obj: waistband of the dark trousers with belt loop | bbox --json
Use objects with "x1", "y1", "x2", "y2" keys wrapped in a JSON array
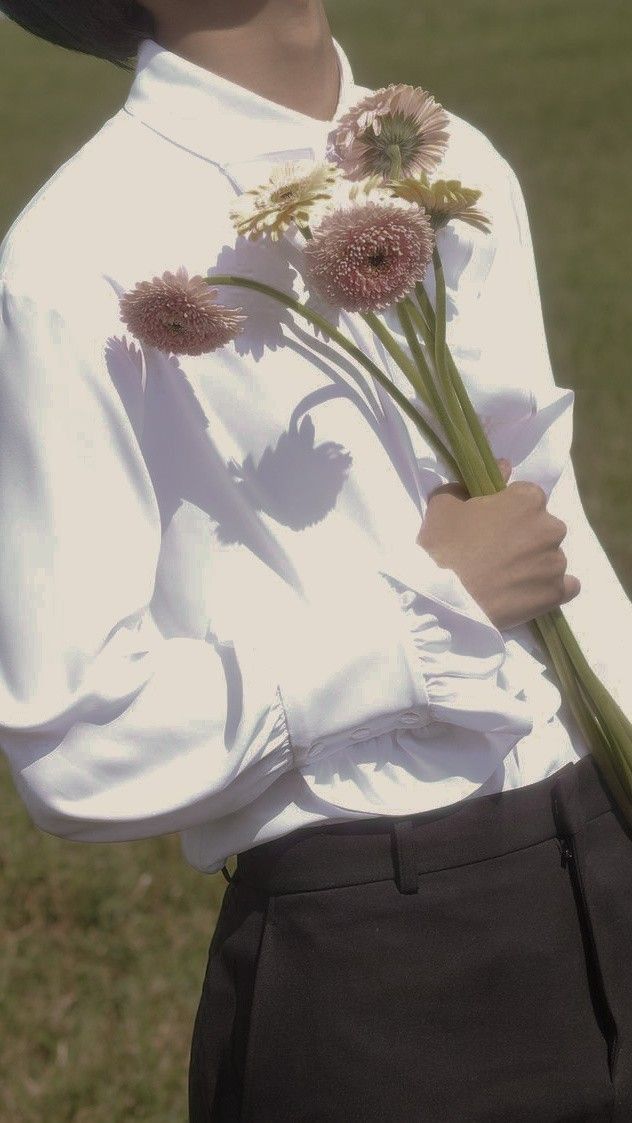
[{"x1": 233, "y1": 755, "x2": 615, "y2": 894}]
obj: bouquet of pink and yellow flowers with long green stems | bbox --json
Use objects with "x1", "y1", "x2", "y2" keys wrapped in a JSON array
[{"x1": 120, "y1": 79, "x2": 632, "y2": 824}]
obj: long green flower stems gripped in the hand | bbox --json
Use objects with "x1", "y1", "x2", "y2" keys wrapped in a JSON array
[{"x1": 209, "y1": 248, "x2": 632, "y2": 827}]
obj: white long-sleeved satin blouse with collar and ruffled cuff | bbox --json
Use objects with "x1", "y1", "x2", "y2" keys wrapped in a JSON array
[{"x1": 0, "y1": 39, "x2": 632, "y2": 873}]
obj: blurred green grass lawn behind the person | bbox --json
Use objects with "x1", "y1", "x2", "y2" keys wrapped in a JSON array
[{"x1": 0, "y1": 0, "x2": 632, "y2": 1123}]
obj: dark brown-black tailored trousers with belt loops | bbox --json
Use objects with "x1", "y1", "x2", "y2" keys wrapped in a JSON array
[{"x1": 189, "y1": 756, "x2": 632, "y2": 1123}]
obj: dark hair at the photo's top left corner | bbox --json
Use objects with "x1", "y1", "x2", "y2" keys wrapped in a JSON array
[{"x1": 0, "y1": 0, "x2": 156, "y2": 71}]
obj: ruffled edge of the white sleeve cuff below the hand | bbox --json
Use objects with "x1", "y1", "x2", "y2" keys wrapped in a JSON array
[{"x1": 294, "y1": 570, "x2": 543, "y2": 815}]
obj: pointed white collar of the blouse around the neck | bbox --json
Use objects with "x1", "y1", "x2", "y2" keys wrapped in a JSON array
[{"x1": 123, "y1": 38, "x2": 363, "y2": 167}]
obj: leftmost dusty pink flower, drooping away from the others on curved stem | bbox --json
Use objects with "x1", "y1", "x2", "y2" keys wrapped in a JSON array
[{"x1": 120, "y1": 266, "x2": 246, "y2": 355}]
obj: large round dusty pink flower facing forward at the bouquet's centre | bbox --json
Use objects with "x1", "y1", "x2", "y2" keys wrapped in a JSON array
[{"x1": 304, "y1": 202, "x2": 434, "y2": 312}]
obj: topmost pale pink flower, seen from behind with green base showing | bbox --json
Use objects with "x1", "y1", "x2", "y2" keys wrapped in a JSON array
[{"x1": 328, "y1": 84, "x2": 449, "y2": 180}]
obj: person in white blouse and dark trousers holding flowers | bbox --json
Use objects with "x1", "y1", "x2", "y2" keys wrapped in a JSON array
[{"x1": 0, "y1": 0, "x2": 632, "y2": 1123}]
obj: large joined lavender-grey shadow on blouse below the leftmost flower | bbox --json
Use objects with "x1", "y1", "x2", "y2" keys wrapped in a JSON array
[{"x1": 106, "y1": 336, "x2": 351, "y2": 570}]
